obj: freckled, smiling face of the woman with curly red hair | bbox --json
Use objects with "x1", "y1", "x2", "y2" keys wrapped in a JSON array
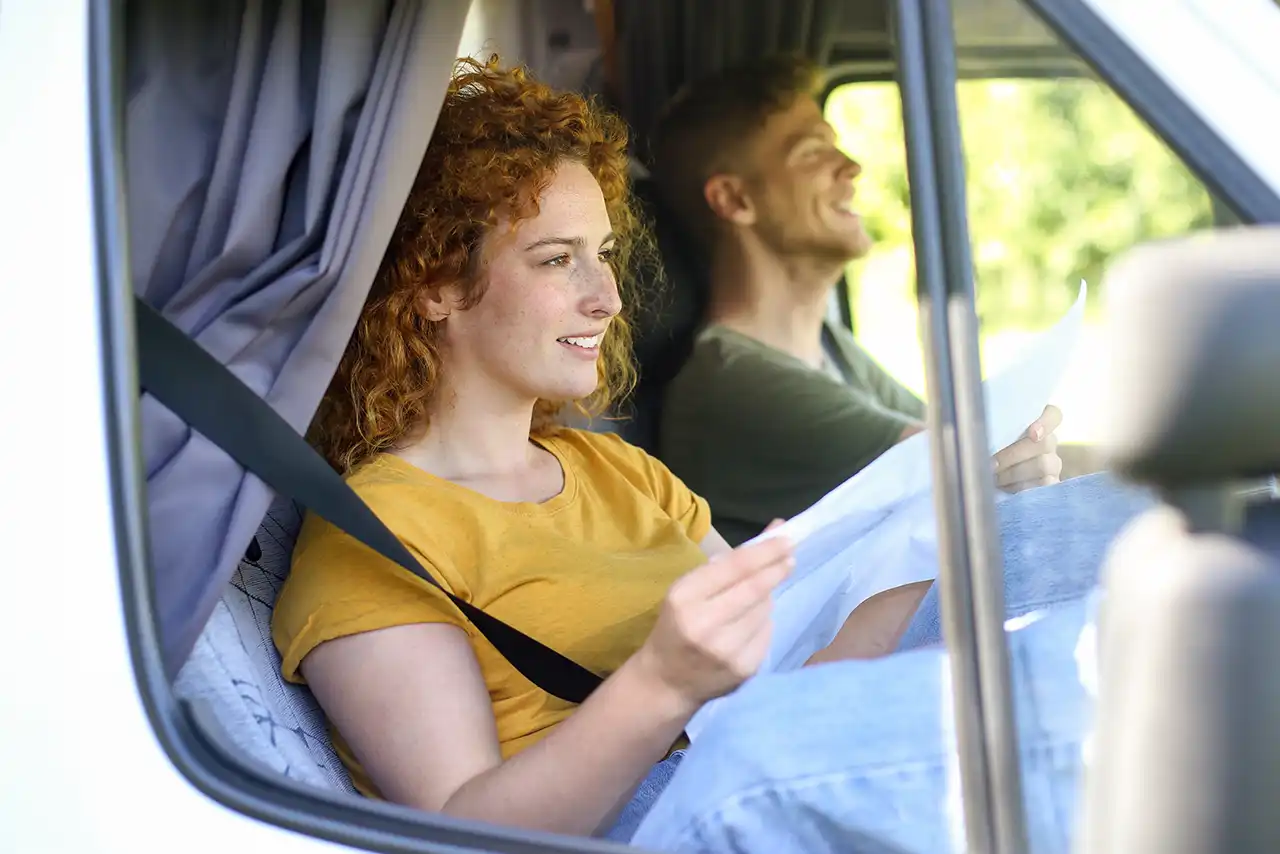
[{"x1": 444, "y1": 161, "x2": 622, "y2": 403}]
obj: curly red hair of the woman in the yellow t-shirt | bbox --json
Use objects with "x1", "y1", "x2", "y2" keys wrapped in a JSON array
[{"x1": 310, "y1": 56, "x2": 653, "y2": 472}]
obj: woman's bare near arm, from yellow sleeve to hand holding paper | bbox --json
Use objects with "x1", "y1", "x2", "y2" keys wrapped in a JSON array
[{"x1": 302, "y1": 540, "x2": 791, "y2": 835}]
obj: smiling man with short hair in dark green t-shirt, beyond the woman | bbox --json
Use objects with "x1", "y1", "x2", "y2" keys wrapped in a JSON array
[{"x1": 653, "y1": 56, "x2": 1062, "y2": 544}]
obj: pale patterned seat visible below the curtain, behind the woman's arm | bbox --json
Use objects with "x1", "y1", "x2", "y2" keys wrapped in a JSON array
[{"x1": 174, "y1": 499, "x2": 356, "y2": 795}]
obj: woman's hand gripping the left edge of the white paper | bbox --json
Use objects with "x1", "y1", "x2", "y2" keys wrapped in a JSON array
[{"x1": 632, "y1": 536, "x2": 795, "y2": 713}]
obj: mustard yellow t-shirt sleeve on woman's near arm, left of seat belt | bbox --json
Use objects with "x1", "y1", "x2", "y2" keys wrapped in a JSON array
[{"x1": 271, "y1": 513, "x2": 475, "y2": 684}]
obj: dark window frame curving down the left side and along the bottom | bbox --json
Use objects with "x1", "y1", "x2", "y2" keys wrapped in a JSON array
[{"x1": 97, "y1": 0, "x2": 1280, "y2": 853}]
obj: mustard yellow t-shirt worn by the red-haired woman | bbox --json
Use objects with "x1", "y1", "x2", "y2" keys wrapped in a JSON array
[{"x1": 271, "y1": 430, "x2": 710, "y2": 796}]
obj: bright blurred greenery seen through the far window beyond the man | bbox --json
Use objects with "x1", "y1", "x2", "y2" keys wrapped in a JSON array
[{"x1": 826, "y1": 79, "x2": 1213, "y2": 444}]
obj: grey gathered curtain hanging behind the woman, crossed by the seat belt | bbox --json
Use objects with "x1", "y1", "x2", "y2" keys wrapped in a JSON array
[{"x1": 124, "y1": 0, "x2": 468, "y2": 675}]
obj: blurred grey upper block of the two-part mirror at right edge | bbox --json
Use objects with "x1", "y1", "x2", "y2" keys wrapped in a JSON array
[{"x1": 1102, "y1": 227, "x2": 1280, "y2": 487}]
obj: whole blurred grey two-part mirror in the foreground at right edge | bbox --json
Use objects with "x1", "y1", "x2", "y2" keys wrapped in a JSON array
[{"x1": 1076, "y1": 228, "x2": 1280, "y2": 854}]
